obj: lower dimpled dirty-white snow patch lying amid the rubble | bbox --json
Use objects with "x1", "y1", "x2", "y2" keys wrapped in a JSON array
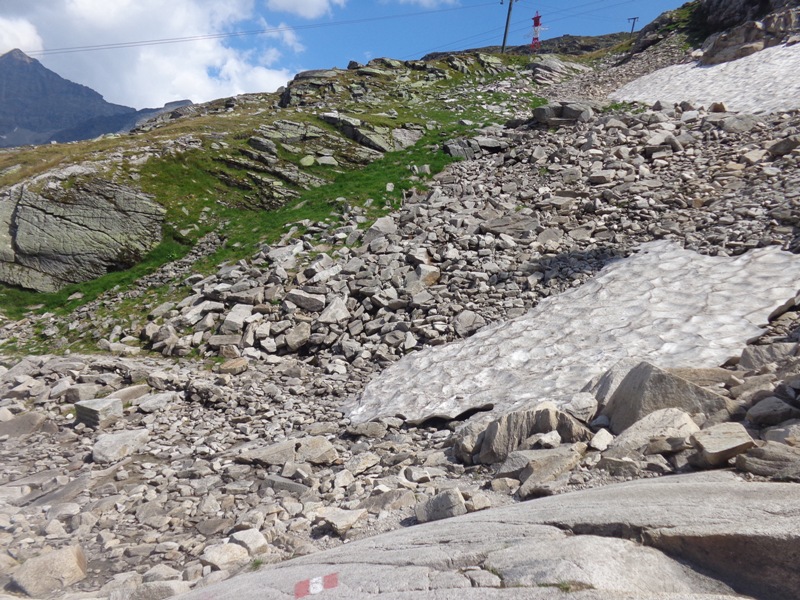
[{"x1": 343, "y1": 241, "x2": 800, "y2": 423}]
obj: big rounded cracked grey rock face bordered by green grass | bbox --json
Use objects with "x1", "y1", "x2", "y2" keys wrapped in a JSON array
[{"x1": 0, "y1": 179, "x2": 165, "y2": 292}]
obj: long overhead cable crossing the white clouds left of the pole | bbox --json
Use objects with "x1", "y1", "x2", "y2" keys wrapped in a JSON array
[{"x1": 25, "y1": 2, "x2": 494, "y2": 56}]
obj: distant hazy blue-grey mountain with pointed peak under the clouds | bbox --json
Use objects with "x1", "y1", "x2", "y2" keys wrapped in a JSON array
[{"x1": 0, "y1": 49, "x2": 191, "y2": 148}]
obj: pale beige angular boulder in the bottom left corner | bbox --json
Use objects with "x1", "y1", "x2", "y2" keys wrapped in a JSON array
[{"x1": 11, "y1": 546, "x2": 86, "y2": 598}]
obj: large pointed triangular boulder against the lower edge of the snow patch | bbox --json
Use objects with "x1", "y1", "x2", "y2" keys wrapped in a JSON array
[{"x1": 603, "y1": 362, "x2": 734, "y2": 434}]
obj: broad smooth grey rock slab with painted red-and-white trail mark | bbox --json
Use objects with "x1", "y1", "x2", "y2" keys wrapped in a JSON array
[{"x1": 173, "y1": 473, "x2": 800, "y2": 600}]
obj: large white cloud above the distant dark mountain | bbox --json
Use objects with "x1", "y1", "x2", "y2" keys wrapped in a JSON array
[{"x1": 0, "y1": 0, "x2": 302, "y2": 108}]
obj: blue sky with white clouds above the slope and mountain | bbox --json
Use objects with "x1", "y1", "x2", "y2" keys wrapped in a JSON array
[{"x1": 0, "y1": 0, "x2": 683, "y2": 108}]
